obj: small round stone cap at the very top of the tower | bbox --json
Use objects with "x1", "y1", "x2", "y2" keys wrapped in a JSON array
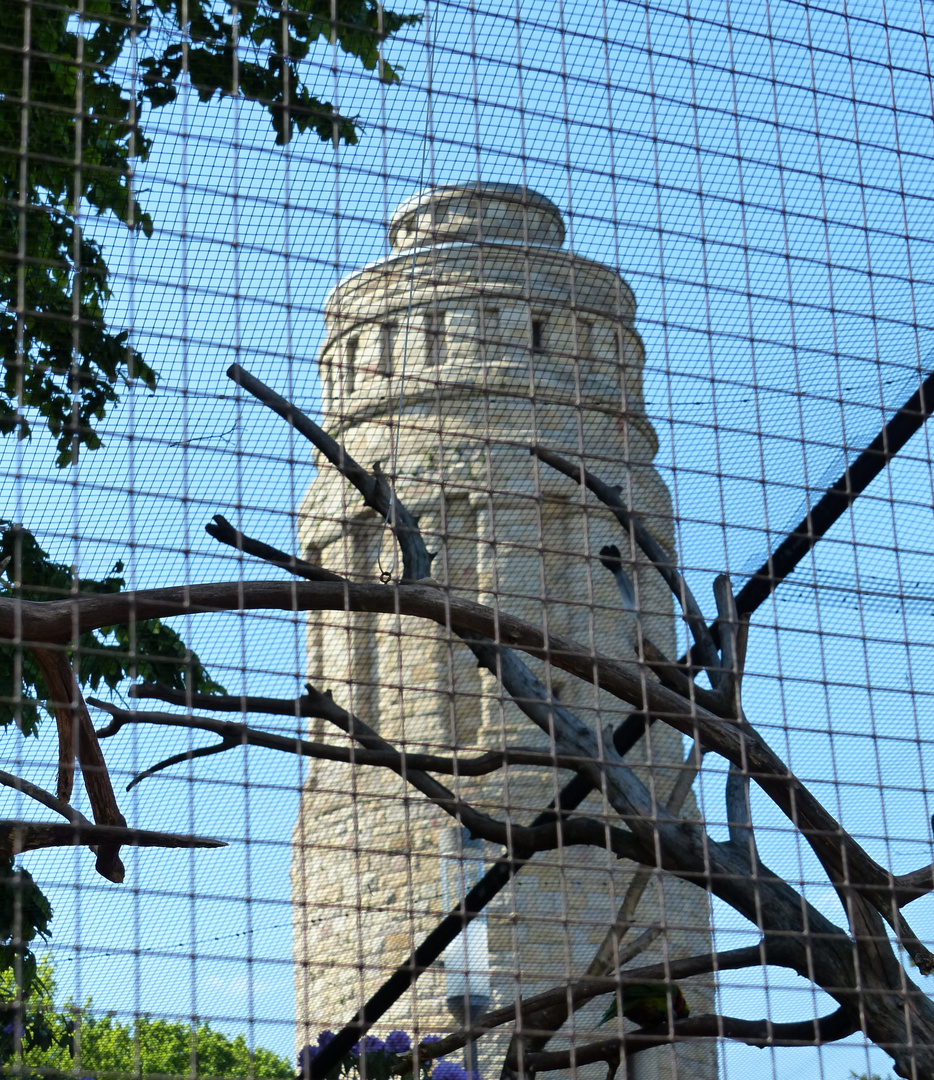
[{"x1": 389, "y1": 184, "x2": 565, "y2": 252}]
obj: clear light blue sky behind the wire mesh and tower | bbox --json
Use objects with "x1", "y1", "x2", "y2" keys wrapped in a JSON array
[{"x1": 0, "y1": 0, "x2": 934, "y2": 1080}]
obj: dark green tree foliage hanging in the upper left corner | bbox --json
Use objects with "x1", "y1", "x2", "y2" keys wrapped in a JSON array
[{"x1": 0, "y1": 0, "x2": 418, "y2": 467}]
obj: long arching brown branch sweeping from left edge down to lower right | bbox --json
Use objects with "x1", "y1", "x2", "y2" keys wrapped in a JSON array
[{"x1": 0, "y1": 581, "x2": 902, "y2": 911}]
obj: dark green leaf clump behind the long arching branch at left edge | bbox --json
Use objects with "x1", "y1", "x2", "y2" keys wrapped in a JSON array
[{"x1": 0, "y1": 521, "x2": 225, "y2": 734}]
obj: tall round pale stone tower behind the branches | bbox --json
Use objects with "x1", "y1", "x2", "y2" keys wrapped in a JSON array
[{"x1": 293, "y1": 185, "x2": 717, "y2": 1080}]
